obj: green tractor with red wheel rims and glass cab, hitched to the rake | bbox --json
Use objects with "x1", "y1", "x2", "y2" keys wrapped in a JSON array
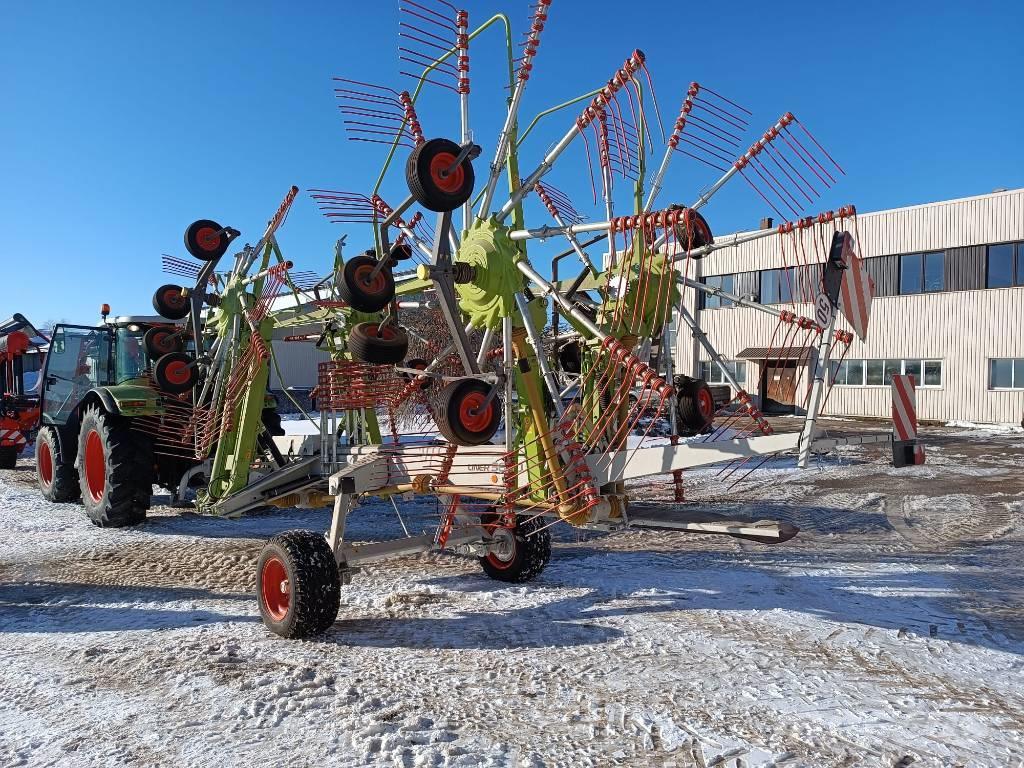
[{"x1": 36, "y1": 315, "x2": 197, "y2": 527}]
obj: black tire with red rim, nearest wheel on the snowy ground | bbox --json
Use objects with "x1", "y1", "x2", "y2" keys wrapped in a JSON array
[{"x1": 256, "y1": 530, "x2": 341, "y2": 639}]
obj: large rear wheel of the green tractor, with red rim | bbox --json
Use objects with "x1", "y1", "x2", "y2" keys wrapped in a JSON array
[{"x1": 75, "y1": 406, "x2": 154, "y2": 528}]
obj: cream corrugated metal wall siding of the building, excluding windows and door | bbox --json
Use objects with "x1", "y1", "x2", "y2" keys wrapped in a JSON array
[{"x1": 679, "y1": 189, "x2": 1024, "y2": 423}]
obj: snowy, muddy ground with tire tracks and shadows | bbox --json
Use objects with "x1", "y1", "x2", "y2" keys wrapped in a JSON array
[{"x1": 0, "y1": 425, "x2": 1024, "y2": 768}]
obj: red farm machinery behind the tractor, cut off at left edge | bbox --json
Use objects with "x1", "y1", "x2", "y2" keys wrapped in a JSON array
[{"x1": 0, "y1": 314, "x2": 41, "y2": 469}]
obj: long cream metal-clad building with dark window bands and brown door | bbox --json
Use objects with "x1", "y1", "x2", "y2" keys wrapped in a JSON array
[{"x1": 675, "y1": 189, "x2": 1024, "y2": 423}]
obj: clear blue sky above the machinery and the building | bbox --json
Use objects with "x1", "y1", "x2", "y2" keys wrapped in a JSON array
[{"x1": 0, "y1": 0, "x2": 1024, "y2": 324}]
